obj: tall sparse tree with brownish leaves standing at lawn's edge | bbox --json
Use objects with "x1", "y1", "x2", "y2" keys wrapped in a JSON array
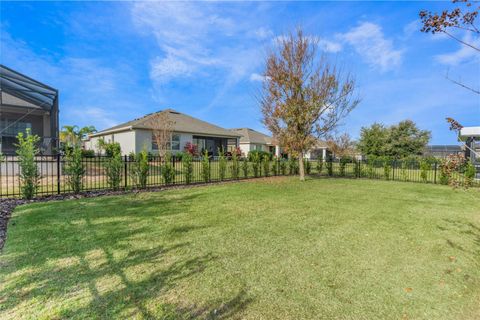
[{"x1": 260, "y1": 29, "x2": 359, "y2": 180}]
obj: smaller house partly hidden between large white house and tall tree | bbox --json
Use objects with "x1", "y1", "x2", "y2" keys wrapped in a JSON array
[{"x1": 230, "y1": 128, "x2": 281, "y2": 157}]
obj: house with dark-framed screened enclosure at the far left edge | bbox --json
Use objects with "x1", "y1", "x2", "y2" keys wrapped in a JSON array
[{"x1": 0, "y1": 64, "x2": 58, "y2": 154}]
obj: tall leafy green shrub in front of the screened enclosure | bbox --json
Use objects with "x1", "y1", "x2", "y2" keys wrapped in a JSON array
[{"x1": 15, "y1": 129, "x2": 40, "y2": 199}]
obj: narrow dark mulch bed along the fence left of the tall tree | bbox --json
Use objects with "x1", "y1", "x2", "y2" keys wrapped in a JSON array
[{"x1": 0, "y1": 177, "x2": 280, "y2": 252}]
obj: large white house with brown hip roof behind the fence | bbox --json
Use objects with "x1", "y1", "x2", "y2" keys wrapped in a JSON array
[{"x1": 85, "y1": 109, "x2": 240, "y2": 156}]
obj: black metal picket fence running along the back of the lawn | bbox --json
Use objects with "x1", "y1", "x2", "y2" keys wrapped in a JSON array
[{"x1": 0, "y1": 155, "x2": 480, "y2": 198}]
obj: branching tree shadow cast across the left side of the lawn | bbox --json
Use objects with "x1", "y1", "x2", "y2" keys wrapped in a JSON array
[{"x1": 0, "y1": 190, "x2": 249, "y2": 318}]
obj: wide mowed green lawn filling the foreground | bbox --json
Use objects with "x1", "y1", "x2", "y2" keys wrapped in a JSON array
[{"x1": 0, "y1": 177, "x2": 480, "y2": 319}]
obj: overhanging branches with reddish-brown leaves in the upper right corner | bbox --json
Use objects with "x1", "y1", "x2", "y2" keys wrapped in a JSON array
[{"x1": 419, "y1": 0, "x2": 480, "y2": 94}]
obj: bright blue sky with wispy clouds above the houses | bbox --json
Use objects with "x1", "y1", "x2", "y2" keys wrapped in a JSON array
[{"x1": 0, "y1": 2, "x2": 480, "y2": 144}]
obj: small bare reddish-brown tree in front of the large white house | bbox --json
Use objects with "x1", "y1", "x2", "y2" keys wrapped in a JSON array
[{"x1": 145, "y1": 112, "x2": 175, "y2": 157}]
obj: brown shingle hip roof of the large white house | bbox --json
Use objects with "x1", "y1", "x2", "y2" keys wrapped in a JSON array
[{"x1": 92, "y1": 109, "x2": 240, "y2": 138}]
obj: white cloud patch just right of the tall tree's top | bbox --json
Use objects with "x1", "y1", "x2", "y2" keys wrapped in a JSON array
[{"x1": 339, "y1": 22, "x2": 403, "y2": 71}]
